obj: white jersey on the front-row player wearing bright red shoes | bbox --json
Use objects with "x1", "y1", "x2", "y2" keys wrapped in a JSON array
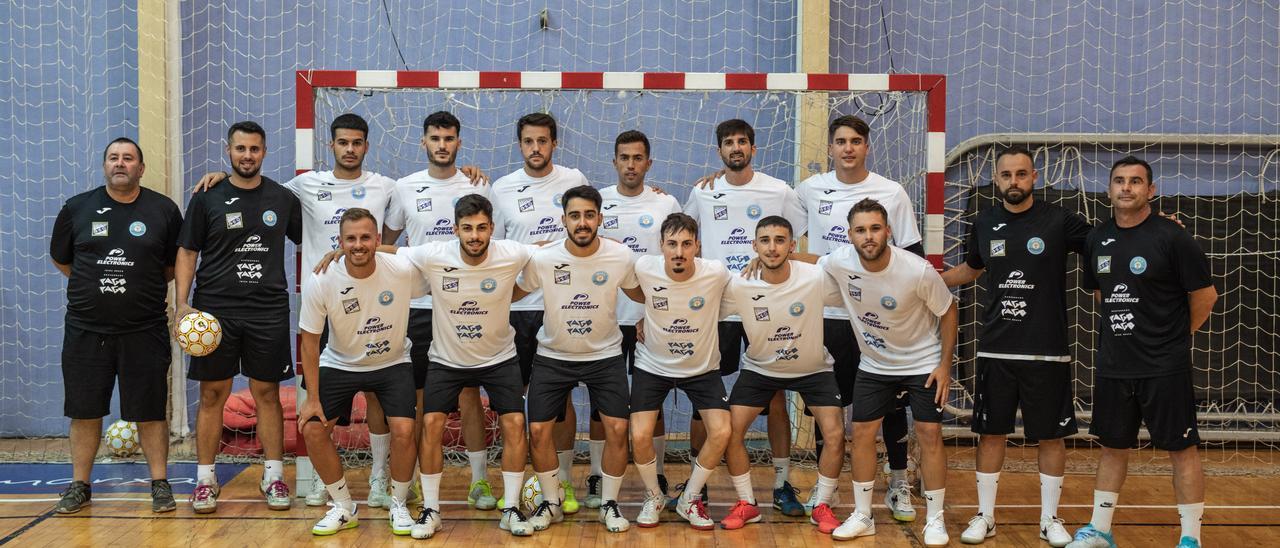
[{"x1": 721, "y1": 261, "x2": 842, "y2": 378}]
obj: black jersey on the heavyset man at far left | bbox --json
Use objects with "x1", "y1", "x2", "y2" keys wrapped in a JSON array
[{"x1": 49, "y1": 187, "x2": 182, "y2": 334}]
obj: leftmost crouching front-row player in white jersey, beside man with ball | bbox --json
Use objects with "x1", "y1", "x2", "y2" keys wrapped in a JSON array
[{"x1": 298, "y1": 207, "x2": 426, "y2": 535}]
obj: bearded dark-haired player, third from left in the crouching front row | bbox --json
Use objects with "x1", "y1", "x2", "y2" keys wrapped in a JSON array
[{"x1": 520, "y1": 186, "x2": 637, "y2": 533}]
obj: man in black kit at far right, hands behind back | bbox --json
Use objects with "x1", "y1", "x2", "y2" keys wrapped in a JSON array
[{"x1": 1068, "y1": 156, "x2": 1217, "y2": 548}]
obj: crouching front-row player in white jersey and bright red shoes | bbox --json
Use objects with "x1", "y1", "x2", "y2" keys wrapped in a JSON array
[{"x1": 721, "y1": 215, "x2": 845, "y2": 534}]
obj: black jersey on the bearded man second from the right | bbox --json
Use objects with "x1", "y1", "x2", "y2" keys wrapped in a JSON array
[{"x1": 965, "y1": 201, "x2": 1092, "y2": 361}]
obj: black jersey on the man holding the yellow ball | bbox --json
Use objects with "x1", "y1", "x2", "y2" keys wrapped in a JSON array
[{"x1": 178, "y1": 177, "x2": 302, "y2": 319}]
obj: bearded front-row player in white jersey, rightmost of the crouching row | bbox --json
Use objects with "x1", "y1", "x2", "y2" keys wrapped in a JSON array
[{"x1": 819, "y1": 198, "x2": 959, "y2": 545}]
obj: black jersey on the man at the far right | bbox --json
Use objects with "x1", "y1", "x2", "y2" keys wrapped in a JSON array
[{"x1": 1083, "y1": 214, "x2": 1212, "y2": 379}]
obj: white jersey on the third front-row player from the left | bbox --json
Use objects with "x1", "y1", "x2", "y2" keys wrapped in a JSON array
[{"x1": 520, "y1": 238, "x2": 637, "y2": 361}]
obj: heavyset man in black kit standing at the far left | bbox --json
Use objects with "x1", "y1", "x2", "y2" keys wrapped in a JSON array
[{"x1": 49, "y1": 137, "x2": 182, "y2": 513}]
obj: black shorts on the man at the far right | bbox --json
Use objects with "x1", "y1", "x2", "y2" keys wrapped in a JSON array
[{"x1": 1089, "y1": 370, "x2": 1199, "y2": 451}]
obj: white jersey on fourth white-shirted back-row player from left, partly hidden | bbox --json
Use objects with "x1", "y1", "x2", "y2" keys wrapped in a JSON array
[{"x1": 600, "y1": 186, "x2": 680, "y2": 325}]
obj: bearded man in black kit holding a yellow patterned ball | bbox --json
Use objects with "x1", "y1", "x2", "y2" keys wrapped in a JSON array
[{"x1": 174, "y1": 122, "x2": 302, "y2": 513}]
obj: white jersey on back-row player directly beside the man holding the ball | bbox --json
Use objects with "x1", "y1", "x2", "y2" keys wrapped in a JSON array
[{"x1": 284, "y1": 172, "x2": 403, "y2": 277}]
